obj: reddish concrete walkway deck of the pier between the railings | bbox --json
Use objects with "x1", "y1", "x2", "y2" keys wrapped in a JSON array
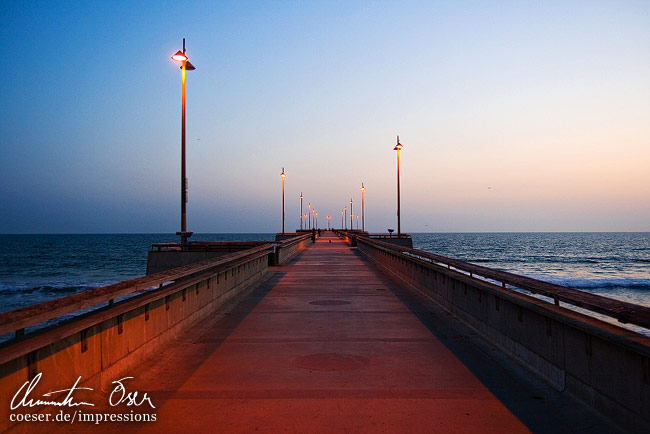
[{"x1": 95, "y1": 233, "x2": 615, "y2": 434}]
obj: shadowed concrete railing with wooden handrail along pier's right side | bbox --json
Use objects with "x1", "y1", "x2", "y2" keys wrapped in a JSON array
[{"x1": 357, "y1": 237, "x2": 650, "y2": 432}]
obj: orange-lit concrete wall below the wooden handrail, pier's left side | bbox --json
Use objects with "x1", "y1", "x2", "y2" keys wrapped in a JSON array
[{"x1": 0, "y1": 251, "x2": 268, "y2": 432}]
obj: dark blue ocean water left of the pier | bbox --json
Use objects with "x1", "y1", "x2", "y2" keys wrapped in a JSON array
[{"x1": 0, "y1": 234, "x2": 275, "y2": 313}]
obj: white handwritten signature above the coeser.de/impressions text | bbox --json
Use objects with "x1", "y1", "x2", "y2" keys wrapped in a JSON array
[{"x1": 11, "y1": 372, "x2": 156, "y2": 410}]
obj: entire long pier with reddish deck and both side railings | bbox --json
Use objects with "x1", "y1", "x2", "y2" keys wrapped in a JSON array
[{"x1": 0, "y1": 232, "x2": 650, "y2": 433}]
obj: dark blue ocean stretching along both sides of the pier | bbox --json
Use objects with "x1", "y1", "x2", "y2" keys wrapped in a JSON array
[{"x1": 0, "y1": 232, "x2": 650, "y2": 336}]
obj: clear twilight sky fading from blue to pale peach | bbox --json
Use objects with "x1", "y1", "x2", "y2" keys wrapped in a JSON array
[{"x1": 0, "y1": 0, "x2": 650, "y2": 233}]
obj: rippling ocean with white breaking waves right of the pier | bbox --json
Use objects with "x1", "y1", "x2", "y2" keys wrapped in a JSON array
[{"x1": 412, "y1": 232, "x2": 650, "y2": 306}]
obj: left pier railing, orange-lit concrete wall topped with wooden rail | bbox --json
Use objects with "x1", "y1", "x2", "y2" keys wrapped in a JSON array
[{"x1": 0, "y1": 244, "x2": 272, "y2": 431}]
